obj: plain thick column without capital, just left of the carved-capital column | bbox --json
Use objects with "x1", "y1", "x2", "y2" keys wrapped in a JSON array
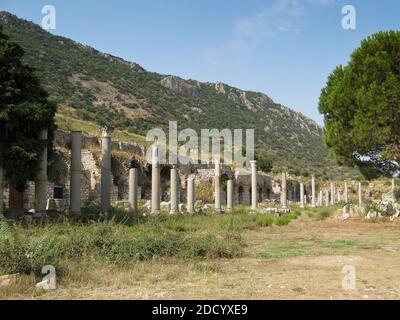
[{"x1": 69, "y1": 131, "x2": 82, "y2": 215}]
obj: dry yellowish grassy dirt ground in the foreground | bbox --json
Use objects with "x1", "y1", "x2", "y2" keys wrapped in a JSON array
[{"x1": 4, "y1": 218, "x2": 400, "y2": 299}]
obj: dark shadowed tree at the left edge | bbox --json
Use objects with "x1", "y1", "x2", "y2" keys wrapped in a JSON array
[{"x1": 0, "y1": 26, "x2": 56, "y2": 192}]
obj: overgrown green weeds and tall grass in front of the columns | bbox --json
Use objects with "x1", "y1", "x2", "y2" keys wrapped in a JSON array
[{"x1": 0, "y1": 207, "x2": 304, "y2": 275}]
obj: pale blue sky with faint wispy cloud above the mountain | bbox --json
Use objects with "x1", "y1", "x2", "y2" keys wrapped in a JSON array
[{"x1": 0, "y1": 0, "x2": 400, "y2": 124}]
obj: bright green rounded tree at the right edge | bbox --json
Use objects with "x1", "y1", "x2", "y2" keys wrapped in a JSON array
[{"x1": 319, "y1": 31, "x2": 400, "y2": 178}]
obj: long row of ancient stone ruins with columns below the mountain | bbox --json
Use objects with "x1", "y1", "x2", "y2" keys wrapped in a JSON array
[{"x1": 0, "y1": 130, "x2": 396, "y2": 219}]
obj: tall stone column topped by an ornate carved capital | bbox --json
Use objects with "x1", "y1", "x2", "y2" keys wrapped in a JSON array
[{"x1": 100, "y1": 130, "x2": 111, "y2": 212}]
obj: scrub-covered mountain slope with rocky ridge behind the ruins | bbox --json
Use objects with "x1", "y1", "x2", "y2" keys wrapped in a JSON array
[{"x1": 0, "y1": 12, "x2": 354, "y2": 177}]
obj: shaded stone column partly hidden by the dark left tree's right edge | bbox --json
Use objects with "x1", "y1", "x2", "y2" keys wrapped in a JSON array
[{"x1": 35, "y1": 129, "x2": 47, "y2": 212}]
